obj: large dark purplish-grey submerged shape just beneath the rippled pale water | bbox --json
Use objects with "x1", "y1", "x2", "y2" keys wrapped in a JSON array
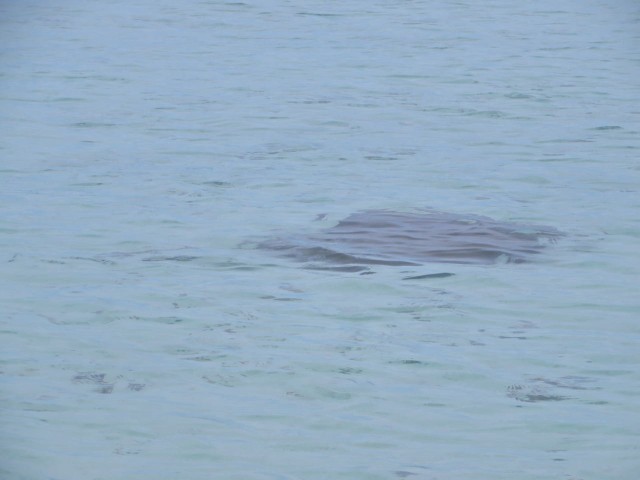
[{"x1": 258, "y1": 210, "x2": 563, "y2": 278}]
